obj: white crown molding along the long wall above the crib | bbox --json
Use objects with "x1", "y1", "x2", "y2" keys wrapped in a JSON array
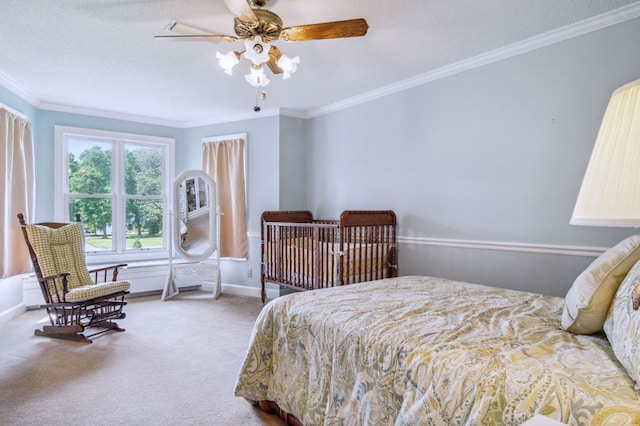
[{"x1": 307, "y1": 2, "x2": 640, "y2": 118}]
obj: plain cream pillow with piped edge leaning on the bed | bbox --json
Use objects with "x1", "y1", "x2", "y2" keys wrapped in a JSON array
[{"x1": 562, "y1": 235, "x2": 640, "y2": 334}]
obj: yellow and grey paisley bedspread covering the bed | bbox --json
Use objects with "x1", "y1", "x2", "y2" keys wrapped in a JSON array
[{"x1": 235, "y1": 276, "x2": 640, "y2": 425}]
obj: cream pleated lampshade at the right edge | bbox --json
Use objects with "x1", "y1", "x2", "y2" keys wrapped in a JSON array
[{"x1": 570, "y1": 80, "x2": 640, "y2": 227}]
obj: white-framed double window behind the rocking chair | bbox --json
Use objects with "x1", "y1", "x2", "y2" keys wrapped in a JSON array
[{"x1": 55, "y1": 126, "x2": 174, "y2": 263}]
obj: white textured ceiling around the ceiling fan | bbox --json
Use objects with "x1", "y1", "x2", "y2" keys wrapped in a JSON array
[{"x1": 0, "y1": 0, "x2": 640, "y2": 126}]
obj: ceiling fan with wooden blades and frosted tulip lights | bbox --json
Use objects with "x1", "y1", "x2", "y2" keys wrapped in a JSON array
[{"x1": 156, "y1": 0, "x2": 369, "y2": 87}]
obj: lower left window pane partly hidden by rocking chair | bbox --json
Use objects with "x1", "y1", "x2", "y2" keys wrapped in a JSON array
[{"x1": 69, "y1": 198, "x2": 113, "y2": 252}]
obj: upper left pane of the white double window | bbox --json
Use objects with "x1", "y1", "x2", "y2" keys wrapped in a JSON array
[{"x1": 68, "y1": 137, "x2": 112, "y2": 194}]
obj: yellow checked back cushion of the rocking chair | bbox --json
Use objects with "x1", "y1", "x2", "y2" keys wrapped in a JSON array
[{"x1": 26, "y1": 223, "x2": 93, "y2": 289}]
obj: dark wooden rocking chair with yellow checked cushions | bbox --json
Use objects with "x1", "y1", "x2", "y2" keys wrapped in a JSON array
[{"x1": 18, "y1": 213, "x2": 131, "y2": 343}]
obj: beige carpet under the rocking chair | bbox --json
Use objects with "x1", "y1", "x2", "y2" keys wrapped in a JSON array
[{"x1": 0, "y1": 291, "x2": 283, "y2": 425}]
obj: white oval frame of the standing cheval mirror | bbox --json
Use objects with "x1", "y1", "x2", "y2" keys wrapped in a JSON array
[{"x1": 171, "y1": 170, "x2": 218, "y2": 262}]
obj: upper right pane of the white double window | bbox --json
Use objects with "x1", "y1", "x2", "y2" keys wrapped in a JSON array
[{"x1": 125, "y1": 144, "x2": 163, "y2": 195}]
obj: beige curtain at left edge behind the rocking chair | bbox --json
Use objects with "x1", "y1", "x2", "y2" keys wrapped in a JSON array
[{"x1": 0, "y1": 107, "x2": 35, "y2": 278}]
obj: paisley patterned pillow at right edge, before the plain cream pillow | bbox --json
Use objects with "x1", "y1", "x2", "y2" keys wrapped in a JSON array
[{"x1": 604, "y1": 262, "x2": 640, "y2": 391}]
